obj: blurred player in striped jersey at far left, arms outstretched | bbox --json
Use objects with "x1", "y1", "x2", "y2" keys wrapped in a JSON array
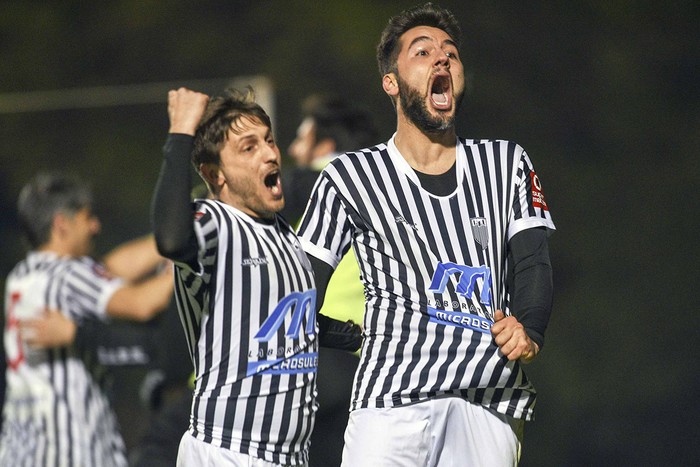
[{"x1": 0, "y1": 173, "x2": 173, "y2": 467}]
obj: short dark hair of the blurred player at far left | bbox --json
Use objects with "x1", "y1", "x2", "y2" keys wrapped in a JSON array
[{"x1": 17, "y1": 172, "x2": 92, "y2": 249}]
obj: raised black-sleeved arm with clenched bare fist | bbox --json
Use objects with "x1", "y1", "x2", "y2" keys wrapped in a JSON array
[{"x1": 151, "y1": 89, "x2": 209, "y2": 265}]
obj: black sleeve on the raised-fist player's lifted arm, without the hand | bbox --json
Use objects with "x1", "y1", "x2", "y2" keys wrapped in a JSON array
[{"x1": 151, "y1": 134, "x2": 197, "y2": 262}]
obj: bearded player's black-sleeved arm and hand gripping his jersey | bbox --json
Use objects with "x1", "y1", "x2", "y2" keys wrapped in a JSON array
[{"x1": 491, "y1": 228, "x2": 553, "y2": 363}]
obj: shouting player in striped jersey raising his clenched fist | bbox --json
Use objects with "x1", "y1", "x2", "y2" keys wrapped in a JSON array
[{"x1": 152, "y1": 88, "x2": 359, "y2": 466}]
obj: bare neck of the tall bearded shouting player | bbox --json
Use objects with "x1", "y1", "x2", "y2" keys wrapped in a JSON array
[{"x1": 394, "y1": 119, "x2": 457, "y2": 175}]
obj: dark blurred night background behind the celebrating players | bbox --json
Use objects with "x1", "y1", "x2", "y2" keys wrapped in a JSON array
[{"x1": 0, "y1": 0, "x2": 700, "y2": 466}]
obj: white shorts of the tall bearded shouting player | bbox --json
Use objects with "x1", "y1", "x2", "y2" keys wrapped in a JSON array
[{"x1": 340, "y1": 397, "x2": 524, "y2": 467}]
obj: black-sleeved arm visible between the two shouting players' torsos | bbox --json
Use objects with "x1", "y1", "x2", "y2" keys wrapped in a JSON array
[{"x1": 308, "y1": 255, "x2": 362, "y2": 352}]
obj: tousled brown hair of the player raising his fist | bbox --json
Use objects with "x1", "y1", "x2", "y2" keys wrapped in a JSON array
[{"x1": 192, "y1": 87, "x2": 272, "y2": 170}]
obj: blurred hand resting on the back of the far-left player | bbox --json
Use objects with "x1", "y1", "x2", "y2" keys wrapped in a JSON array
[{"x1": 19, "y1": 309, "x2": 77, "y2": 349}]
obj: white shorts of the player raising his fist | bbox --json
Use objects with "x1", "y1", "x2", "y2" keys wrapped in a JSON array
[{"x1": 177, "y1": 432, "x2": 304, "y2": 467}]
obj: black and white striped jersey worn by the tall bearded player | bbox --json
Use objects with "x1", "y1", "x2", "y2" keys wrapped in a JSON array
[{"x1": 298, "y1": 138, "x2": 554, "y2": 419}]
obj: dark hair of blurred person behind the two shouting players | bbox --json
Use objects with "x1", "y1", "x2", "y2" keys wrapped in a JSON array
[{"x1": 302, "y1": 94, "x2": 377, "y2": 152}]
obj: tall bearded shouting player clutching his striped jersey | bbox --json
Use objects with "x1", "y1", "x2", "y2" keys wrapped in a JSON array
[{"x1": 298, "y1": 4, "x2": 554, "y2": 466}]
